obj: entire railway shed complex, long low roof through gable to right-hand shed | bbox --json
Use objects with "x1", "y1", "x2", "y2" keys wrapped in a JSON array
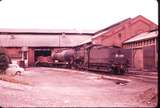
[{"x1": 0, "y1": 15, "x2": 158, "y2": 70}]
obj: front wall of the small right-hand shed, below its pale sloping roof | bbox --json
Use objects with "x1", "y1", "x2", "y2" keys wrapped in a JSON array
[{"x1": 123, "y1": 38, "x2": 157, "y2": 71}]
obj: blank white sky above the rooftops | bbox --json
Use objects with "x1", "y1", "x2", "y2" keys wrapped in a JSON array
[{"x1": 0, "y1": 0, "x2": 158, "y2": 30}]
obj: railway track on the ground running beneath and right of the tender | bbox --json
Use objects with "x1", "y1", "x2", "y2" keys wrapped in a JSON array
[{"x1": 37, "y1": 68, "x2": 158, "y2": 83}]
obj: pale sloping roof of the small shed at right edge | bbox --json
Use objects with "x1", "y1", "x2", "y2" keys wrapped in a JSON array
[{"x1": 123, "y1": 30, "x2": 158, "y2": 43}]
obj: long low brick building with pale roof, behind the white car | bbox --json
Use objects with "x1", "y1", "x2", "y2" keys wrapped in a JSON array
[{"x1": 0, "y1": 29, "x2": 93, "y2": 66}]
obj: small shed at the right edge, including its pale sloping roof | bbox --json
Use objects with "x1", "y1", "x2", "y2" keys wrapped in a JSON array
[{"x1": 123, "y1": 30, "x2": 158, "y2": 71}]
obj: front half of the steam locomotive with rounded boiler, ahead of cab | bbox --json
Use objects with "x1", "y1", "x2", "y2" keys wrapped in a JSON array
[{"x1": 35, "y1": 49, "x2": 75, "y2": 68}]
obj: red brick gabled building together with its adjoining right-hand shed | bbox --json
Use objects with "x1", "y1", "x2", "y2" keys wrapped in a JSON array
[{"x1": 92, "y1": 15, "x2": 158, "y2": 70}]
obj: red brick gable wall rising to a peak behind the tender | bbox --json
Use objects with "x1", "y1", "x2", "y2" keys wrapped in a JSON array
[{"x1": 92, "y1": 16, "x2": 157, "y2": 46}]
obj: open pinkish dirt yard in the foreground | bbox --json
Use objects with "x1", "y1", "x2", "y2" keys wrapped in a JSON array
[{"x1": 0, "y1": 67, "x2": 157, "y2": 107}]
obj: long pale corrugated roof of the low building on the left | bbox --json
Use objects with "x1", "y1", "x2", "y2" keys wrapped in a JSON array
[{"x1": 0, "y1": 35, "x2": 91, "y2": 47}]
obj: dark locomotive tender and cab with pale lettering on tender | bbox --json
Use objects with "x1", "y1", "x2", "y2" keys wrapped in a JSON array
[{"x1": 74, "y1": 45, "x2": 131, "y2": 74}]
